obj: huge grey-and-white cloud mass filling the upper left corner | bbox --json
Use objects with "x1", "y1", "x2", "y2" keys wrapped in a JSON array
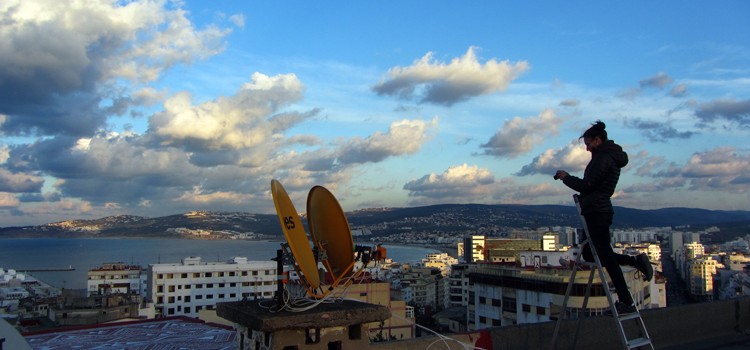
[{"x1": 0, "y1": 0, "x2": 229, "y2": 136}]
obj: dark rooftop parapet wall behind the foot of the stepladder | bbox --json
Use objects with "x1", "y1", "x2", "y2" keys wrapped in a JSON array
[{"x1": 370, "y1": 297, "x2": 750, "y2": 350}]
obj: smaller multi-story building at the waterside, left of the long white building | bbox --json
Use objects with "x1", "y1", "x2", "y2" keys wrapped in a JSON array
[{"x1": 86, "y1": 262, "x2": 145, "y2": 295}]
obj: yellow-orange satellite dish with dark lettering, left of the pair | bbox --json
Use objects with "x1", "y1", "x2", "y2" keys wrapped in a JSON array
[{"x1": 271, "y1": 180, "x2": 320, "y2": 294}]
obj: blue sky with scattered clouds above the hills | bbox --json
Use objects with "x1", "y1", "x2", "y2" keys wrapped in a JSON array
[{"x1": 0, "y1": 0, "x2": 750, "y2": 227}]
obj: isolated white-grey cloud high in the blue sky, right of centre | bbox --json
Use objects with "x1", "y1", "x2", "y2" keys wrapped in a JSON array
[{"x1": 373, "y1": 47, "x2": 529, "y2": 106}]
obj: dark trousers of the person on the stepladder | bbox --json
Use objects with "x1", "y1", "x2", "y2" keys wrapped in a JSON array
[{"x1": 582, "y1": 213, "x2": 635, "y2": 305}]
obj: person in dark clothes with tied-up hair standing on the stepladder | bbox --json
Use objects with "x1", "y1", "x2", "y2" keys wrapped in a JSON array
[{"x1": 555, "y1": 120, "x2": 654, "y2": 315}]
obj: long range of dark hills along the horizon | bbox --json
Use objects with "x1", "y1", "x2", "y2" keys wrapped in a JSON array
[{"x1": 0, "y1": 204, "x2": 750, "y2": 239}]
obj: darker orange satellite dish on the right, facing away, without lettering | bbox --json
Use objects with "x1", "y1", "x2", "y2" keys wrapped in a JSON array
[{"x1": 307, "y1": 186, "x2": 354, "y2": 285}]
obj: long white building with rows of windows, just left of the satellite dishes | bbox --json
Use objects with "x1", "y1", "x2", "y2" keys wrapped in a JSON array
[{"x1": 147, "y1": 257, "x2": 277, "y2": 317}]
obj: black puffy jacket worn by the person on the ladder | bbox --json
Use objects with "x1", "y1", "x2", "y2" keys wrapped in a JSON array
[{"x1": 563, "y1": 140, "x2": 628, "y2": 214}]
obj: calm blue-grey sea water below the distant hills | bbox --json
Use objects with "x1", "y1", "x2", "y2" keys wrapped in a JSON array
[{"x1": 0, "y1": 238, "x2": 438, "y2": 289}]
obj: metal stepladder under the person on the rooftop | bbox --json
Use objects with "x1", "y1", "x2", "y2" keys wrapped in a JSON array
[{"x1": 549, "y1": 194, "x2": 654, "y2": 350}]
